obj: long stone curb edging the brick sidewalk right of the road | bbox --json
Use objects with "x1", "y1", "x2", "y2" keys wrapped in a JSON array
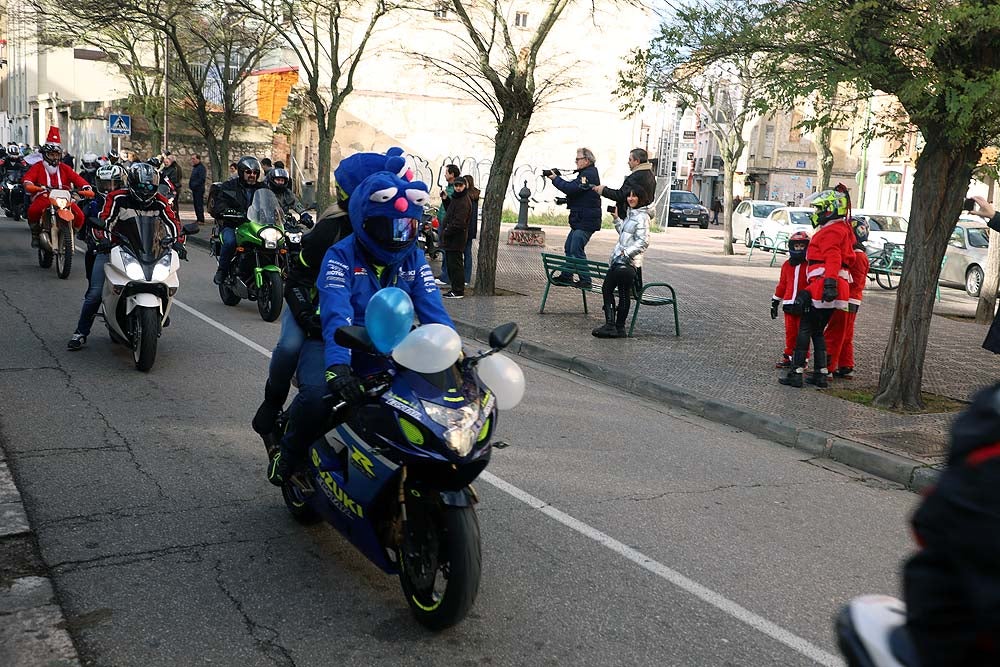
[{"x1": 452, "y1": 318, "x2": 940, "y2": 493}]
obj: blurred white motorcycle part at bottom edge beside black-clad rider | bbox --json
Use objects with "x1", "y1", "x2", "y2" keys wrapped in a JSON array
[{"x1": 837, "y1": 595, "x2": 917, "y2": 667}]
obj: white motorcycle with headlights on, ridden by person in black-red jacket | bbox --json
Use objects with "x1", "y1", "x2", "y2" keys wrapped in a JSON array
[{"x1": 101, "y1": 213, "x2": 198, "y2": 372}]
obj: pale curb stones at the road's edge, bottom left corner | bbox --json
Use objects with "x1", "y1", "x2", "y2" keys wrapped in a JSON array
[{"x1": 0, "y1": 460, "x2": 80, "y2": 667}]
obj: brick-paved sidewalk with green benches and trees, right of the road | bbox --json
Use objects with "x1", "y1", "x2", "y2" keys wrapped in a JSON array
[{"x1": 182, "y1": 213, "x2": 998, "y2": 490}]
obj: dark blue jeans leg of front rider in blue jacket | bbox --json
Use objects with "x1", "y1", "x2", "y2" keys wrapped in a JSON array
[{"x1": 281, "y1": 338, "x2": 330, "y2": 461}]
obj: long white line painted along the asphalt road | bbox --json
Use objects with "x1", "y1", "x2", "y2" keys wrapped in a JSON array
[{"x1": 174, "y1": 299, "x2": 844, "y2": 667}]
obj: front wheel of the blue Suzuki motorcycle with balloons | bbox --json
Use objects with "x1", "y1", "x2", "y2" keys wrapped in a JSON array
[{"x1": 399, "y1": 505, "x2": 482, "y2": 631}]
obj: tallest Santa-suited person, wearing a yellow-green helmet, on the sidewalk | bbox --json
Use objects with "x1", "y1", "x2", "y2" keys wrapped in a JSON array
[{"x1": 778, "y1": 184, "x2": 855, "y2": 389}]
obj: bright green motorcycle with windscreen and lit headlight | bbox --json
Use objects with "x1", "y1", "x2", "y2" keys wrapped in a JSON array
[{"x1": 212, "y1": 188, "x2": 288, "y2": 322}]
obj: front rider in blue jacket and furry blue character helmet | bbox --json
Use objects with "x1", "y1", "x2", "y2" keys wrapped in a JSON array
[{"x1": 268, "y1": 171, "x2": 455, "y2": 486}]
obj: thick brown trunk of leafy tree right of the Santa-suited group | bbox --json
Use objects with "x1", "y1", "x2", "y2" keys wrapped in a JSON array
[{"x1": 874, "y1": 140, "x2": 980, "y2": 410}]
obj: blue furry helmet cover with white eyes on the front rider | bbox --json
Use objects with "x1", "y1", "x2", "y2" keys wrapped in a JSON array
[{"x1": 348, "y1": 171, "x2": 430, "y2": 266}]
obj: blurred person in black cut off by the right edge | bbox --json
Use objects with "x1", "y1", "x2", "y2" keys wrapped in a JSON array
[{"x1": 903, "y1": 383, "x2": 1000, "y2": 667}]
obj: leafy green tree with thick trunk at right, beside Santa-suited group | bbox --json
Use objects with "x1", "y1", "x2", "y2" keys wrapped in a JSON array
[{"x1": 632, "y1": 0, "x2": 1000, "y2": 410}]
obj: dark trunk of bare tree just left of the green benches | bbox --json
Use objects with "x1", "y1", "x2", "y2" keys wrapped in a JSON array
[{"x1": 475, "y1": 111, "x2": 531, "y2": 296}]
